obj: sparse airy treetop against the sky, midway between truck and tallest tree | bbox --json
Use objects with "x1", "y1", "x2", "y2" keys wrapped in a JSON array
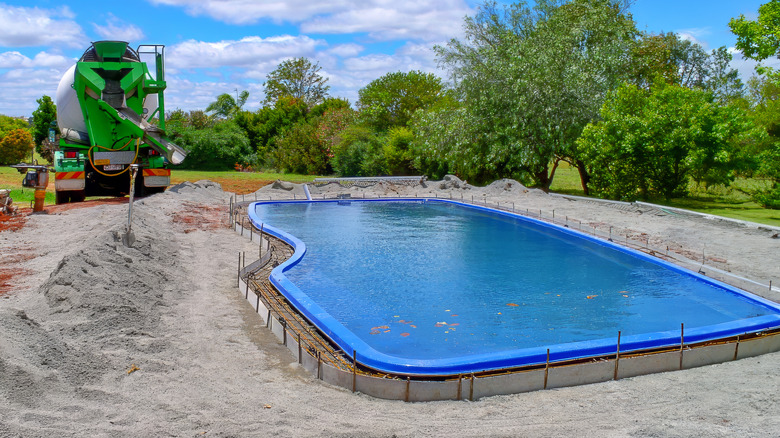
[{"x1": 263, "y1": 58, "x2": 330, "y2": 108}]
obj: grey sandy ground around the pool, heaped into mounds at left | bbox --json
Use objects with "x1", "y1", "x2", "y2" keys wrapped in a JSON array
[{"x1": 0, "y1": 178, "x2": 780, "y2": 437}]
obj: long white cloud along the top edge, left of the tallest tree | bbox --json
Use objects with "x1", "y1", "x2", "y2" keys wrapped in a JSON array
[{"x1": 151, "y1": 0, "x2": 474, "y2": 41}]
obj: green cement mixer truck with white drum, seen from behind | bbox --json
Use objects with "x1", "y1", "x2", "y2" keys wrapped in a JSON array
[{"x1": 54, "y1": 41, "x2": 186, "y2": 204}]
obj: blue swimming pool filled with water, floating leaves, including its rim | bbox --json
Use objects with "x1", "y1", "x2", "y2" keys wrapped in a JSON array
[{"x1": 249, "y1": 200, "x2": 780, "y2": 375}]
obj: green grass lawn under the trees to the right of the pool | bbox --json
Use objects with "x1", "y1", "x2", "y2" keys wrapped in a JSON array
[{"x1": 550, "y1": 163, "x2": 780, "y2": 227}]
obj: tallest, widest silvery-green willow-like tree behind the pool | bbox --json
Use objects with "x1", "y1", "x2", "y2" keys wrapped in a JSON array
[{"x1": 418, "y1": 0, "x2": 637, "y2": 190}]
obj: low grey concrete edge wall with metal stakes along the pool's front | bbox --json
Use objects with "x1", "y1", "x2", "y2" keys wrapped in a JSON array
[{"x1": 238, "y1": 279, "x2": 780, "y2": 402}]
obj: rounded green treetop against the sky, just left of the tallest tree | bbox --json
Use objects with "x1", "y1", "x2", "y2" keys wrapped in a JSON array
[{"x1": 357, "y1": 71, "x2": 444, "y2": 131}]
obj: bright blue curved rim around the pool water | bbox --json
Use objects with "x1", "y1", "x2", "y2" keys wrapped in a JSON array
[{"x1": 248, "y1": 199, "x2": 780, "y2": 376}]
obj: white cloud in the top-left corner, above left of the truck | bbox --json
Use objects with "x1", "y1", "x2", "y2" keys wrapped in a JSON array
[{"x1": 0, "y1": 3, "x2": 87, "y2": 47}]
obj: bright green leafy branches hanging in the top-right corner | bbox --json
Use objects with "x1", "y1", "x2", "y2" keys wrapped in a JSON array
[{"x1": 729, "y1": 0, "x2": 780, "y2": 79}]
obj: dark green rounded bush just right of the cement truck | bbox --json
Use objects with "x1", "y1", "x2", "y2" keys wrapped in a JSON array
[{"x1": 171, "y1": 120, "x2": 254, "y2": 170}]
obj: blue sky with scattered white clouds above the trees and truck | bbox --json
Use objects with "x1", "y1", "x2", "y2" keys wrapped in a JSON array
[{"x1": 0, "y1": 0, "x2": 767, "y2": 116}]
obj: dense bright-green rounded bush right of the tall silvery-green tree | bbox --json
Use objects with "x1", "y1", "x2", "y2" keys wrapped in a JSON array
[{"x1": 579, "y1": 84, "x2": 747, "y2": 200}]
